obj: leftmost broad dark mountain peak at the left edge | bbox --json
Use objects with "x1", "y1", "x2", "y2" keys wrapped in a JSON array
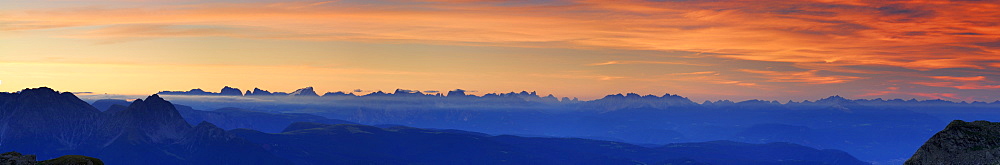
[{"x1": 0, "y1": 87, "x2": 104, "y2": 155}]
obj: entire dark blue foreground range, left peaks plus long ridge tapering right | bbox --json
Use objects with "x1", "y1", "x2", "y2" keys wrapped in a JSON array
[{"x1": 0, "y1": 87, "x2": 866, "y2": 164}]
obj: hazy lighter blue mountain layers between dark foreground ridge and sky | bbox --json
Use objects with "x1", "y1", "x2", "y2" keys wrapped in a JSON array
[{"x1": 145, "y1": 86, "x2": 1000, "y2": 164}]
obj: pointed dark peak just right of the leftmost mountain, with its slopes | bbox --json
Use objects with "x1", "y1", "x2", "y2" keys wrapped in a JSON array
[{"x1": 97, "y1": 95, "x2": 288, "y2": 164}]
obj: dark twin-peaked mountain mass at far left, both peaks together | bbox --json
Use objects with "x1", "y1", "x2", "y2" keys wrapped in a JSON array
[{"x1": 0, "y1": 87, "x2": 287, "y2": 164}]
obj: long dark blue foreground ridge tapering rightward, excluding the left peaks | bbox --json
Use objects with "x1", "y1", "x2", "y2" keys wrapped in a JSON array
[{"x1": 230, "y1": 122, "x2": 866, "y2": 164}]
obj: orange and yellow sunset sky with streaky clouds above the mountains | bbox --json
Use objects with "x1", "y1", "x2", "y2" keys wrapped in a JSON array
[{"x1": 0, "y1": 0, "x2": 1000, "y2": 101}]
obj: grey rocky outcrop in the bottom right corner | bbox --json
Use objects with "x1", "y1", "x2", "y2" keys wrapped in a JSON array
[{"x1": 906, "y1": 120, "x2": 1000, "y2": 165}]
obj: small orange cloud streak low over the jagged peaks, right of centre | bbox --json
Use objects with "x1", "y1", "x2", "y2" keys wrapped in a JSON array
[{"x1": 739, "y1": 69, "x2": 862, "y2": 84}]
